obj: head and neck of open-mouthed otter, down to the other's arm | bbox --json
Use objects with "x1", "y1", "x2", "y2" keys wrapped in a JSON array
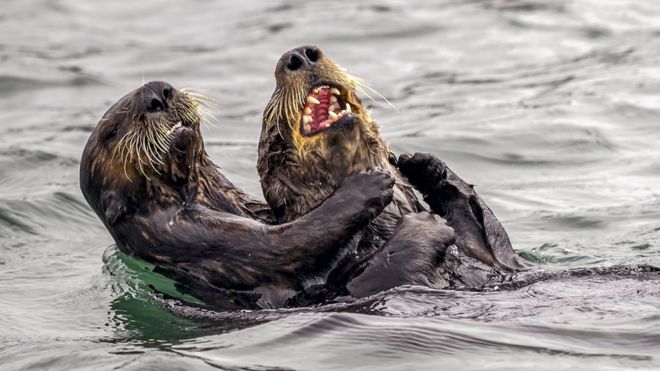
[{"x1": 257, "y1": 46, "x2": 389, "y2": 220}]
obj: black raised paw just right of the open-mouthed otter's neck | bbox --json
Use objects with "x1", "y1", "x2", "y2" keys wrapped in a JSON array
[{"x1": 398, "y1": 152, "x2": 447, "y2": 194}]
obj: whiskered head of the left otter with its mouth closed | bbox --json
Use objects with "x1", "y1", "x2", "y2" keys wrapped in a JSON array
[{"x1": 80, "y1": 82, "x2": 206, "y2": 225}]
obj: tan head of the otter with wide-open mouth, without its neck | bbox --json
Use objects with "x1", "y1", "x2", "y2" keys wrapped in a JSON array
[{"x1": 262, "y1": 46, "x2": 386, "y2": 177}]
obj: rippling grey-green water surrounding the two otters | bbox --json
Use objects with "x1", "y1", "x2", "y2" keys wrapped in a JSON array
[{"x1": 0, "y1": 0, "x2": 660, "y2": 370}]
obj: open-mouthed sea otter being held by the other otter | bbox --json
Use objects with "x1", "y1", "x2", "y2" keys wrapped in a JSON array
[{"x1": 257, "y1": 46, "x2": 528, "y2": 296}]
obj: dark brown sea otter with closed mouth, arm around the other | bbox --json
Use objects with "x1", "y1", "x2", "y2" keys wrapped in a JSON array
[{"x1": 80, "y1": 82, "x2": 394, "y2": 309}]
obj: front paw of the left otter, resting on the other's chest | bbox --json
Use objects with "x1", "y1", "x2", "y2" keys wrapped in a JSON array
[{"x1": 339, "y1": 169, "x2": 394, "y2": 217}]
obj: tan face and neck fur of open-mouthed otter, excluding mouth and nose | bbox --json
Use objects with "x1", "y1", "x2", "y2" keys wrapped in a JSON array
[{"x1": 257, "y1": 50, "x2": 415, "y2": 222}]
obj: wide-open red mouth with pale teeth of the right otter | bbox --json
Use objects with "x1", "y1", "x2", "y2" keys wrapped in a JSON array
[{"x1": 301, "y1": 85, "x2": 352, "y2": 135}]
